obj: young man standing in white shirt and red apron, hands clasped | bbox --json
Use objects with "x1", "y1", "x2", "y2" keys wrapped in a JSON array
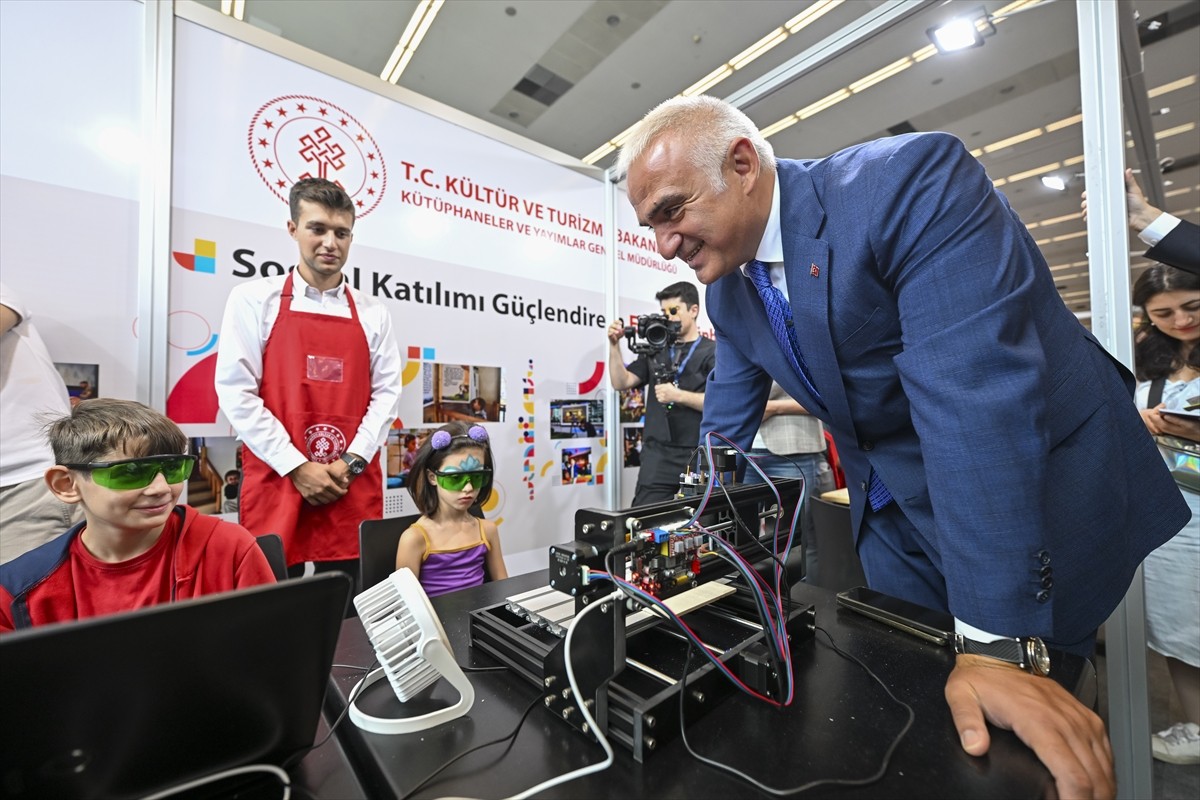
[{"x1": 216, "y1": 179, "x2": 401, "y2": 576}]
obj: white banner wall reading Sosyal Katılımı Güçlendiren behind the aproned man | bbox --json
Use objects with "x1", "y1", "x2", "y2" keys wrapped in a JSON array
[{"x1": 168, "y1": 22, "x2": 710, "y2": 572}]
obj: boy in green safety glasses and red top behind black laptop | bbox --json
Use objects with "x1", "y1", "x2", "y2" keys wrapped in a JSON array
[{"x1": 0, "y1": 399, "x2": 275, "y2": 633}]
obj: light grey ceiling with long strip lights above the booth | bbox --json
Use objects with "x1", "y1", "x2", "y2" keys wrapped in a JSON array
[{"x1": 200, "y1": 0, "x2": 1200, "y2": 323}]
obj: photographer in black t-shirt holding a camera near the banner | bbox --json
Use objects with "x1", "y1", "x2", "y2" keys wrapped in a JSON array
[{"x1": 608, "y1": 281, "x2": 716, "y2": 506}]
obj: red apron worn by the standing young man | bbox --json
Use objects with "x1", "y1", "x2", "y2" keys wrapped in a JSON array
[{"x1": 240, "y1": 273, "x2": 383, "y2": 566}]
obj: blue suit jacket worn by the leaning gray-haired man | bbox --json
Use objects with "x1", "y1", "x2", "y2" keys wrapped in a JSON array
[{"x1": 701, "y1": 133, "x2": 1188, "y2": 643}]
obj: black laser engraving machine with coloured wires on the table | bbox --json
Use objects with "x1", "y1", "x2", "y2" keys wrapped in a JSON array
[{"x1": 470, "y1": 470, "x2": 812, "y2": 762}]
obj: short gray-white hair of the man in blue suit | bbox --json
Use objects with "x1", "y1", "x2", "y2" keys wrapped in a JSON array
[{"x1": 617, "y1": 95, "x2": 775, "y2": 192}]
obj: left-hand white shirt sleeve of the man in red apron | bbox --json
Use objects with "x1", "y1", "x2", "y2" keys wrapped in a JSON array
[{"x1": 215, "y1": 278, "x2": 308, "y2": 475}]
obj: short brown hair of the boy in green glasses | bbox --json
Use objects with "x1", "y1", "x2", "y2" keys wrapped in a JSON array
[{"x1": 46, "y1": 397, "x2": 187, "y2": 464}]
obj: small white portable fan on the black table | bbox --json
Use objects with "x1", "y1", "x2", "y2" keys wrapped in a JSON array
[{"x1": 350, "y1": 567, "x2": 475, "y2": 733}]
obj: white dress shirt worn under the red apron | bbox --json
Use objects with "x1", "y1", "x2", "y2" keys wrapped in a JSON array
[{"x1": 216, "y1": 270, "x2": 403, "y2": 475}]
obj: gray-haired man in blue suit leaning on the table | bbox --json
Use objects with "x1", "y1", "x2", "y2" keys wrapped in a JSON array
[{"x1": 618, "y1": 97, "x2": 1187, "y2": 796}]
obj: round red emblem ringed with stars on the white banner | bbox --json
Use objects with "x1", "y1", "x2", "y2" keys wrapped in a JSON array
[{"x1": 247, "y1": 95, "x2": 388, "y2": 219}]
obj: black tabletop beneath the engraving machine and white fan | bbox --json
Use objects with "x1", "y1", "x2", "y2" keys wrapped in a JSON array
[{"x1": 322, "y1": 572, "x2": 1094, "y2": 799}]
